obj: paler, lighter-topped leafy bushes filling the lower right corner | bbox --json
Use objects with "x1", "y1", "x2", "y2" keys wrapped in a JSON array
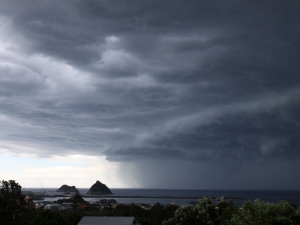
[{"x1": 163, "y1": 197, "x2": 300, "y2": 225}]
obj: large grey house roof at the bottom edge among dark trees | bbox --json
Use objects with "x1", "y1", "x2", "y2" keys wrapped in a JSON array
[{"x1": 78, "y1": 216, "x2": 138, "y2": 225}]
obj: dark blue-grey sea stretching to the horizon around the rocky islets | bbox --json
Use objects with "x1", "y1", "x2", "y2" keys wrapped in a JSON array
[{"x1": 22, "y1": 188, "x2": 300, "y2": 207}]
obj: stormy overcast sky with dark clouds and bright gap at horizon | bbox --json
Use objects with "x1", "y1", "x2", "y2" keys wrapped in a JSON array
[{"x1": 0, "y1": 0, "x2": 300, "y2": 189}]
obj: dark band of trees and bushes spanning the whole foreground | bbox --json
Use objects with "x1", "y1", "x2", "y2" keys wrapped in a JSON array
[{"x1": 0, "y1": 180, "x2": 300, "y2": 225}]
